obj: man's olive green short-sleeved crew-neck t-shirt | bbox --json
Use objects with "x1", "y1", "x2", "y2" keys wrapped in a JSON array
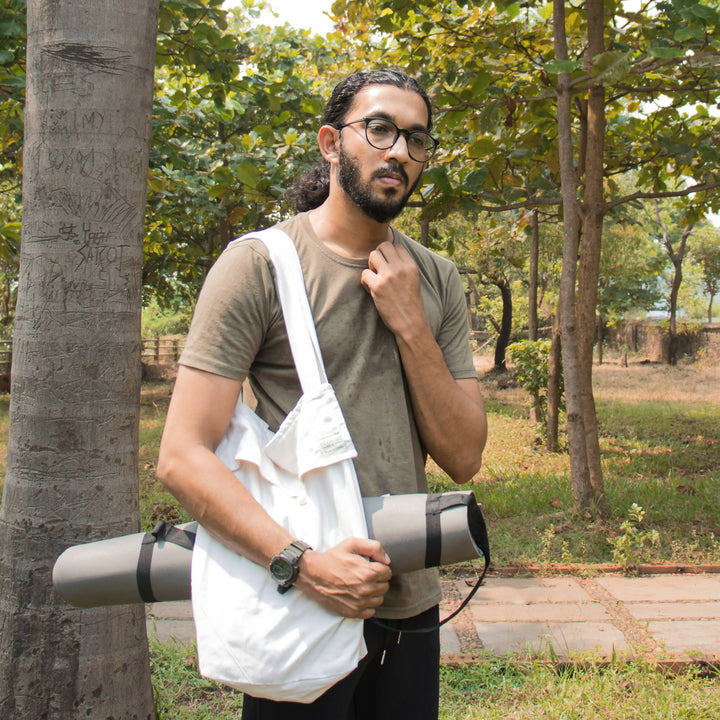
[{"x1": 180, "y1": 213, "x2": 476, "y2": 619}]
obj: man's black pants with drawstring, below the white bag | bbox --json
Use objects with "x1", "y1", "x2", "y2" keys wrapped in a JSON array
[{"x1": 242, "y1": 606, "x2": 440, "y2": 720}]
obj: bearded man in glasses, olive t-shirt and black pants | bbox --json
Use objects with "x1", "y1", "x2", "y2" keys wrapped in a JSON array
[{"x1": 158, "y1": 70, "x2": 487, "y2": 720}]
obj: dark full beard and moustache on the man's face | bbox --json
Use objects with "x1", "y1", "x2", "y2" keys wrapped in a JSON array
[{"x1": 338, "y1": 145, "x2": 422, "y2": 223}]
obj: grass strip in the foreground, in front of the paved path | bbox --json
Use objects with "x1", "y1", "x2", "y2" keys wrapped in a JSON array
[{"x1": 150, "y1": 641, "x2": 720, "y2": 720}]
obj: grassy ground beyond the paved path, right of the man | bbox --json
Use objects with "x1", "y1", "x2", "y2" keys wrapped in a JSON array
[{"x1": 422, "y1": 363, "x2": 720, "y2": 570}]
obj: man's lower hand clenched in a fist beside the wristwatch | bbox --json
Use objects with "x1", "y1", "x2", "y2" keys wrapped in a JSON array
[{"x1": 295, "y1": 538, "x2": 392, "y2": 619}]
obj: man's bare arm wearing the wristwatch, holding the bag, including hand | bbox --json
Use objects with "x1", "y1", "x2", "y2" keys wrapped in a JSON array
[{"x1": 157, "y1": 365, "x2": 391, "y2": 618}]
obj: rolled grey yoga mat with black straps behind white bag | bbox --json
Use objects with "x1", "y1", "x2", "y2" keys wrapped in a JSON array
[{"x1": 53, "y1": 492, "x2": 490, "y2": 608}]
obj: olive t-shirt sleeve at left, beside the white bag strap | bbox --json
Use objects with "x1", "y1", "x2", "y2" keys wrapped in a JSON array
[{"x1": 180, "y1": 241, "x2": 275, "y2": 380}]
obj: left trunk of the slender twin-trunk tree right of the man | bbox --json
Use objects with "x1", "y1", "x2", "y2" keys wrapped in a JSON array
[{"x1": 553, "y1": 2, "x2": 592, "y2": 509}]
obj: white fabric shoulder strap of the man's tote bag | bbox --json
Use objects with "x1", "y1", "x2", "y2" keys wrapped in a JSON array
[{"x1": 231, "y1": 227, "x2": 327, "y2": 393}]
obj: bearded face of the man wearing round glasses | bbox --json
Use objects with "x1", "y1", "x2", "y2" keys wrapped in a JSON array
[{"x1": 338, "y1": 85, "x2": 428, "y2": 223}]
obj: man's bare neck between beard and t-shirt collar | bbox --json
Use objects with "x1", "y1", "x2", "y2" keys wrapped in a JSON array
[{"x1": 309, "y1": 190, "x2": 393, "y2": 258}]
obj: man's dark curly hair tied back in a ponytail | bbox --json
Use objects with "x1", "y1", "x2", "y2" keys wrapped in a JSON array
[{"x1": 285, "y1": 68, "x2": 432, "y2": 212}]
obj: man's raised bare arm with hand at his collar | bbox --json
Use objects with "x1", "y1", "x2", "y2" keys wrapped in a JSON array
[{"x1": 362, "y1": 242, "x2": 487, "y2": 483}]
